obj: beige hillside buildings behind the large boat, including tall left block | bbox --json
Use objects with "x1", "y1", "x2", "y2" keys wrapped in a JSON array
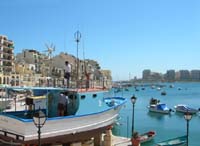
[{"x1": 0, "y1": 35, "x2": 112, "y2": 88}]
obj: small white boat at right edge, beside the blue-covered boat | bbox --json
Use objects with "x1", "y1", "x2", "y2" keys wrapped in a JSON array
[{"x1": 174, "y1": 104, "x2": 199, "y2": 114}]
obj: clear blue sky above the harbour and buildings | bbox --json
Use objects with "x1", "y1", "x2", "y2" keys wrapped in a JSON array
[{"x1": 0, "y1": 0, "x2": 200, "y2": 80}]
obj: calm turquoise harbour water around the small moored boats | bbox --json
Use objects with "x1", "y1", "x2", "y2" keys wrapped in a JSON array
[{"x1": 110, "y1": 83, "x2": 200, "y2": 146}]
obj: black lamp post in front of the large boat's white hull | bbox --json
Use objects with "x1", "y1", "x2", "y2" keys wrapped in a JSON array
[{"x1": 33, "y1": 108, "x2": 46, "y2": 146}]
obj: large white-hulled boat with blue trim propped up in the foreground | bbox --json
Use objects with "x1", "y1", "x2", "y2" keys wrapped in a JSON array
[{"x1": 0, "y1": 91, "x2": 126, "y2": 144}]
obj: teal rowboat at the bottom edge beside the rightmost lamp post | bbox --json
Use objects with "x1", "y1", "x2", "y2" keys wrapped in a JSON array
[{"x1": 156, "y1": 135, "x2": 187, "y2": 146}]
